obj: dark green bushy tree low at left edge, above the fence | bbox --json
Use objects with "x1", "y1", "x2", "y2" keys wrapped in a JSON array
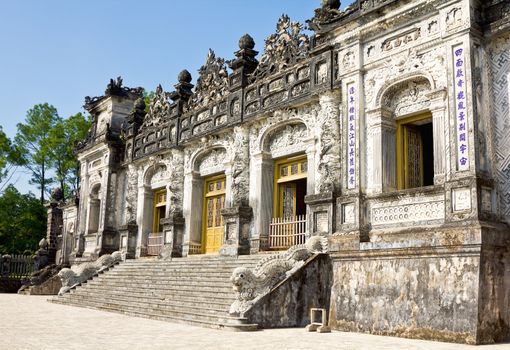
[{"x1": 0, "y1": 185, "x2": 46, "y2": 255}]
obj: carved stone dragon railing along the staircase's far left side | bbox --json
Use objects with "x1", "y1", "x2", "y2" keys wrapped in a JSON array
[{"x1": 58, "y1": 252, "x2": 122, "y2": 295}]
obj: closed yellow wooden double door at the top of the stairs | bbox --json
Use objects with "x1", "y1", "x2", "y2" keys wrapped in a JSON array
[{"x1": 202, "y1": 177, "x2": 225, "y2": 254}]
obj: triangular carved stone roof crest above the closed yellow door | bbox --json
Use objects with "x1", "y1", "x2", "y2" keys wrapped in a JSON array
[{"x1": 188, "y1": 49, "x2": 228, "y2": 110}]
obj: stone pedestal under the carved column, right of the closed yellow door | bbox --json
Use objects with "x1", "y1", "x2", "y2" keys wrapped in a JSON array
[{"x1": 220, "y1": 206, "x2": 252, "y2": 256}]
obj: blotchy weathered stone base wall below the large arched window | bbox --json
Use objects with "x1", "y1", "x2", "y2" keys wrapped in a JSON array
[{"x1": 330, "y1": 248, "x2": 480, "y2": 344}]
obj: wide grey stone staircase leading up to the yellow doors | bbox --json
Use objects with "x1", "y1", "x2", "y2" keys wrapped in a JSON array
[{"x1": 49, "y1": 255, "x2": 263, "y2": 330}]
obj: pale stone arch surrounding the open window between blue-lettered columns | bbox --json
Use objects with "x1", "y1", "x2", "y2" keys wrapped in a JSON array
[{"x1": 367, "y1": 73, "x2": 446, "y2": 192}]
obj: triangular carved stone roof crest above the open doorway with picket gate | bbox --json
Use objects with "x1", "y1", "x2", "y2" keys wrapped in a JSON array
[{"x1": 253, "y1": 15, "x2": 310, "y2": 79}]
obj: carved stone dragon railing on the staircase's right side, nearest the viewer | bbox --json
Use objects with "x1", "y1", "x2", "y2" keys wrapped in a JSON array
[{"x1": 229, "y1": 236, "x2": 328, "y2": 317}]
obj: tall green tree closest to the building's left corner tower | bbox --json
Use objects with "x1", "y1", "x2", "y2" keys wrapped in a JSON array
[{"x1": 49, "y1": 113, "x2": 91, "y2": 198}]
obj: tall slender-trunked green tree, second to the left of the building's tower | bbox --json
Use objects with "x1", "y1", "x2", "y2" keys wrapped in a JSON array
[{"x1": 14, "y1": 103, "x2": 61, "y2": 204}]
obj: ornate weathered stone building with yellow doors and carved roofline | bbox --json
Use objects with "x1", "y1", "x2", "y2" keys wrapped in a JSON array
[{"x1": 51, "y1": 0, "x2": 510, "y2": 343}]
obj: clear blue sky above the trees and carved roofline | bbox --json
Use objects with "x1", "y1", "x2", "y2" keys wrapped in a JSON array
[{"x1": 0, "y1": 0, "x2": 345, "y2": 192}]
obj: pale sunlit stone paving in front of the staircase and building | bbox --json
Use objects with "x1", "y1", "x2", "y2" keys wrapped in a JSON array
[{"x1": 0, "y1": 294, "x2": 510, "y2": 350}]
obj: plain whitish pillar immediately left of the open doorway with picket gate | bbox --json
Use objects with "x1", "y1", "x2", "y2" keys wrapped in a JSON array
[{"x1": 249, "y1": 152, "x2": 272, "y2": 253}]
